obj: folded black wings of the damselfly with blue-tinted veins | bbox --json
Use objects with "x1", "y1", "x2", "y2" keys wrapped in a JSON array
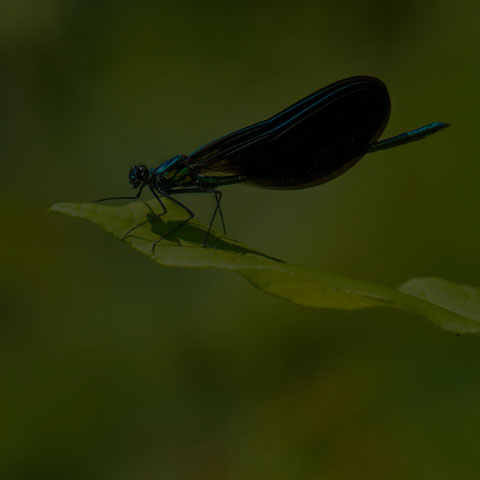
[{"x1": 190, "y1": 77, "x2": 390, "y2": 189}]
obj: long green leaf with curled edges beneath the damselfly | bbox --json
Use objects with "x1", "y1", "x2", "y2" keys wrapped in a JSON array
[{"x1": 50, "y1": 200, "x2": 480, "y2": 333}]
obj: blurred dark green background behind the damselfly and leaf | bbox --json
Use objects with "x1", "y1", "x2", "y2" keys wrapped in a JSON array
[{"x1": 0, "y1": 0, "x2": 480, "y2": 480}]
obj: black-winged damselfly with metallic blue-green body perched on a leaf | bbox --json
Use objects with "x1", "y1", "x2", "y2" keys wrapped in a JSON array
[{"x1": 97, "y1": 76, "x2": 449, "y2": 251}]
